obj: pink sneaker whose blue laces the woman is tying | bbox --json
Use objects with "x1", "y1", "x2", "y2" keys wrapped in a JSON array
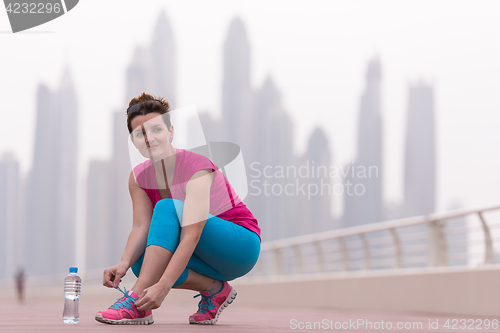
[{"x1": 95, "y1": 288, "x2": 153, "y2": 325}]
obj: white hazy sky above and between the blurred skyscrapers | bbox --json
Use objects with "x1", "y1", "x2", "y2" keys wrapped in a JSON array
[{"x1": 0, "y1": 0, "x2": 500, "y2": 217}]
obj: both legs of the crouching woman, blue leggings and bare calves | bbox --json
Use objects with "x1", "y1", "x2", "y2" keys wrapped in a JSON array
[{"x1": 132, "y1": 199, "x2": 260, "y2": 294}]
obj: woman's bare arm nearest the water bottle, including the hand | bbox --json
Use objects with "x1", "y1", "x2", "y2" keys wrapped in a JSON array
[{"x1": 103, "y1": 171, "x2": 153, "y2": 288}]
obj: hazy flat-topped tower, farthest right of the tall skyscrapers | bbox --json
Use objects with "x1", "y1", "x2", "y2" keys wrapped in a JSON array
[{"x1": 404, "y1": 82, "x2": 436, "y2": 216}]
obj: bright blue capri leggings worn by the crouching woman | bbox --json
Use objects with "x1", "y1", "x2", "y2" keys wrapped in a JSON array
[{"x1": 132, "y1": 199, "x2": 260, "y2": 288}]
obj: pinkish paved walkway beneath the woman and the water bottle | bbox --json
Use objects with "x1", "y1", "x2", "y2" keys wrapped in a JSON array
[{"x1": 0, "y1": 284, "x2": 498, "y2": 333}]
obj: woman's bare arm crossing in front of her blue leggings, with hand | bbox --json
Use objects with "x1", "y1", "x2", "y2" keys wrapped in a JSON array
[{"x1": 136, "y1": 169, "x2": 215, "y2": 310}]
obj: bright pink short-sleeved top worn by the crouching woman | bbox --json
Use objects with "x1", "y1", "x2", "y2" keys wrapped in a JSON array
[{"x1": 134, "y1": 149, "x2": 260, "y2": 238}]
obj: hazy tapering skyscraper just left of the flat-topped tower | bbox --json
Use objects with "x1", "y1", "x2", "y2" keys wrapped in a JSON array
[{"x1": 342, "y1": 58, "x2": 382, "y2": 227}]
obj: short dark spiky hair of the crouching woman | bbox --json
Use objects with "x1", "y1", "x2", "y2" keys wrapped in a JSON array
[{"x1": 127, "y1": 93, "x2": 172, "y2": 133}]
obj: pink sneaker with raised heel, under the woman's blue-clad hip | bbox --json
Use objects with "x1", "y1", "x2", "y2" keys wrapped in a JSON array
[{"x1": 189, "y1": 281, "x2": 236, "y2": 325}]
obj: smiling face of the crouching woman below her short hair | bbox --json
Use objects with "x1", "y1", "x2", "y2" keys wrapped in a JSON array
[{"x1": 130, "y1": 112, "x2": 174, "y2": 162}]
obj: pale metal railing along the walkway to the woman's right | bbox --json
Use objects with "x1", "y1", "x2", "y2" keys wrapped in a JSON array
[{"x1": 252, "y1": 202, "x2": 500, "y2": 279}]
